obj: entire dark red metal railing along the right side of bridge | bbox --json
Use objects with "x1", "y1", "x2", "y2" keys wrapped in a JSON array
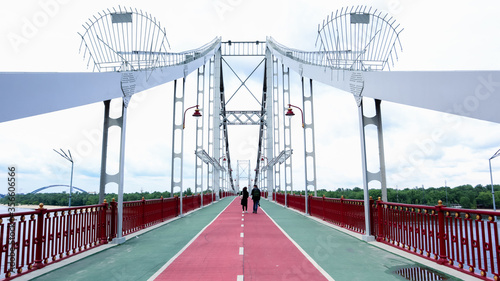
[{"x1": 274, "y1": 193, "x2": 500, "y2": 280}]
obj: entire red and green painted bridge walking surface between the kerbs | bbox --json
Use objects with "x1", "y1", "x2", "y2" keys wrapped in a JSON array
[{"x1": 18, "y1": 198, "x2": 466, "y2": 281}]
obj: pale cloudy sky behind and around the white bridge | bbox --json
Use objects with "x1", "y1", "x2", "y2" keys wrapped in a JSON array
[{"x1": 0, "y1": 0, "x2": 500, "y2": 196}]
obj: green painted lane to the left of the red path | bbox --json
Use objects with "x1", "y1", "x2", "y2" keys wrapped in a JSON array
[{"x1": 32, "y1": 197, "x2": 233, "y2": 281}]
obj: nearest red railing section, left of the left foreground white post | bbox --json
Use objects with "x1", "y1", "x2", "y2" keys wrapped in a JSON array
[{"x1": 0, "y1": 204, "x2": 110, "y2": 279}]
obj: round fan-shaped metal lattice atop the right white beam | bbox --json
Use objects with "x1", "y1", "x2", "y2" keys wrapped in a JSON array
[{"x1": 316, "y1": 6, "x2": 403, "y2": 71}]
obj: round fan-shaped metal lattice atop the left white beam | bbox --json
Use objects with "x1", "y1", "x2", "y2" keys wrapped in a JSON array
[{"x1": 80, "y1": 6, "x2": 171, "y2": 72}]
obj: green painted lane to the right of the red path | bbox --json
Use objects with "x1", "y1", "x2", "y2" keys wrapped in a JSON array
[{"x1": 261, "y1": 200, "x2": 459, "y2": 281}]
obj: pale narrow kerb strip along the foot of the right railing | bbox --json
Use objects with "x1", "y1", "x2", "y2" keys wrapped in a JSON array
[{"x1": 270, "y1": 201, "x2": 483, "y2": 281}]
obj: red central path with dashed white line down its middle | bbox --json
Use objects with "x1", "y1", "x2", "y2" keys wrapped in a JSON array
[{"x1": 155, "y1": 198, "x2": 327, "y2": 281}]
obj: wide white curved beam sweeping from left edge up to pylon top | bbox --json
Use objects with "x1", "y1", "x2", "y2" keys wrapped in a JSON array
[{"x1": 0, "y1": 38, "x2": 220, "y2": 123}]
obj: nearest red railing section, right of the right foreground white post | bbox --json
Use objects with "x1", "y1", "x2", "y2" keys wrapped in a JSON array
[{"x1": 377, "y1": 198, "x2": 500, "y2": 280}]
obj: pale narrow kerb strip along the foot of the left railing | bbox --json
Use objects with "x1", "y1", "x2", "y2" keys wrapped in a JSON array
[{"x1": 16, "y1": 201, "x2": 218, "y2": 281}]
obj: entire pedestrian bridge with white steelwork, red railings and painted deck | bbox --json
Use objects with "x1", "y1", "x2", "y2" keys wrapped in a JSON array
[{"x1": 0, "y1": 3, "x2": 500, "y2": 280}]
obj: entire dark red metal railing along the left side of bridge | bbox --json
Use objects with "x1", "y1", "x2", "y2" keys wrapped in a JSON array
[{"x1": 0, "y1": 193, "x2": 215, "y2": 280}]
